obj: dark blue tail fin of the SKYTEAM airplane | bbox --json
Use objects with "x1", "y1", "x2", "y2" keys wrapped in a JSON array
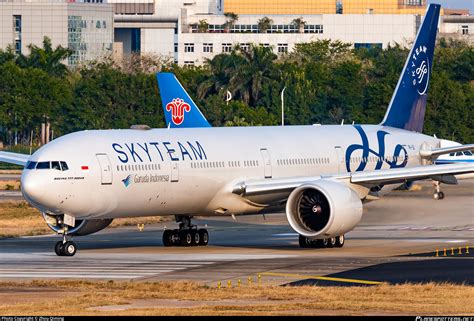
[{"x1": 381, "y1": 4, "x2": 441, "y2": 132}]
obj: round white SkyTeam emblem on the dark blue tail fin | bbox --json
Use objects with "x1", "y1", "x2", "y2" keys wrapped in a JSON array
[{"x1": 411, "y1": 45, "x2": 430, "y2": 95}]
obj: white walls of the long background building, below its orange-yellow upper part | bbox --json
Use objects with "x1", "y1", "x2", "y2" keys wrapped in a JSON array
[{"x1": 108, "y1": 0, "x2": 474, "y2": 65}]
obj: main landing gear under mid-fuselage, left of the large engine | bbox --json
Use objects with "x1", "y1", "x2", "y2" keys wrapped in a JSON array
[{"x1": 163, "y1": 216, "x2": 209, "y2": 246}]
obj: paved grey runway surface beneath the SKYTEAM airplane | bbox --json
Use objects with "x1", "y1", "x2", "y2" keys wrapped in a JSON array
[{"x1": 0, "y1": 181, "x2": 474, "y2": 286}]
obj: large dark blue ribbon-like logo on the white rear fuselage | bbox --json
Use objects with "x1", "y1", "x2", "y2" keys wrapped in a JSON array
[{"x1": 346, "y1": 125, "x2": 408, "y2": 172}]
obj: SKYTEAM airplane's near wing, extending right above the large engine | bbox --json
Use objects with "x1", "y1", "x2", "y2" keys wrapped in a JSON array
[{"x1": 232, "y1": 163, "x2": 474, "y2": 197}]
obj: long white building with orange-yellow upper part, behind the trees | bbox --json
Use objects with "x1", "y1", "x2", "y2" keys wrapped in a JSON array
[{"x1": 109, "y1": 0, "x2": 472, "y2": 65}]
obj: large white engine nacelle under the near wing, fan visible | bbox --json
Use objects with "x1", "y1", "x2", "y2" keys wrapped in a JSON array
[{"x1": 286, "y1": 179, "x2": 362, "y2": 239}]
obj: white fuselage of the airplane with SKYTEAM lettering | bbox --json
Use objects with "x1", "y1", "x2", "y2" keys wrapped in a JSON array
[{"x1": 22, "y1": 125, "x2": 439, "y2": 219}]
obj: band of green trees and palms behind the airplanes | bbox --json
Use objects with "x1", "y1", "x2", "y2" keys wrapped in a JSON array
[{"x1": 0, "y1": 36, "x2": 474, "y2": 146}]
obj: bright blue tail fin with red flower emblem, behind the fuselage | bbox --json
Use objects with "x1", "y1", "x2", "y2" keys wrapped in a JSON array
[{"x1": 156, "y1": 72, "x2": 211, "y2": 128}]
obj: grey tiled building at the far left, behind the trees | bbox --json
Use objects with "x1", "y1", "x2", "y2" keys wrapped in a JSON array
[{"x1": 0, "y1": 0, "x2": 114, "y2": 66}]
